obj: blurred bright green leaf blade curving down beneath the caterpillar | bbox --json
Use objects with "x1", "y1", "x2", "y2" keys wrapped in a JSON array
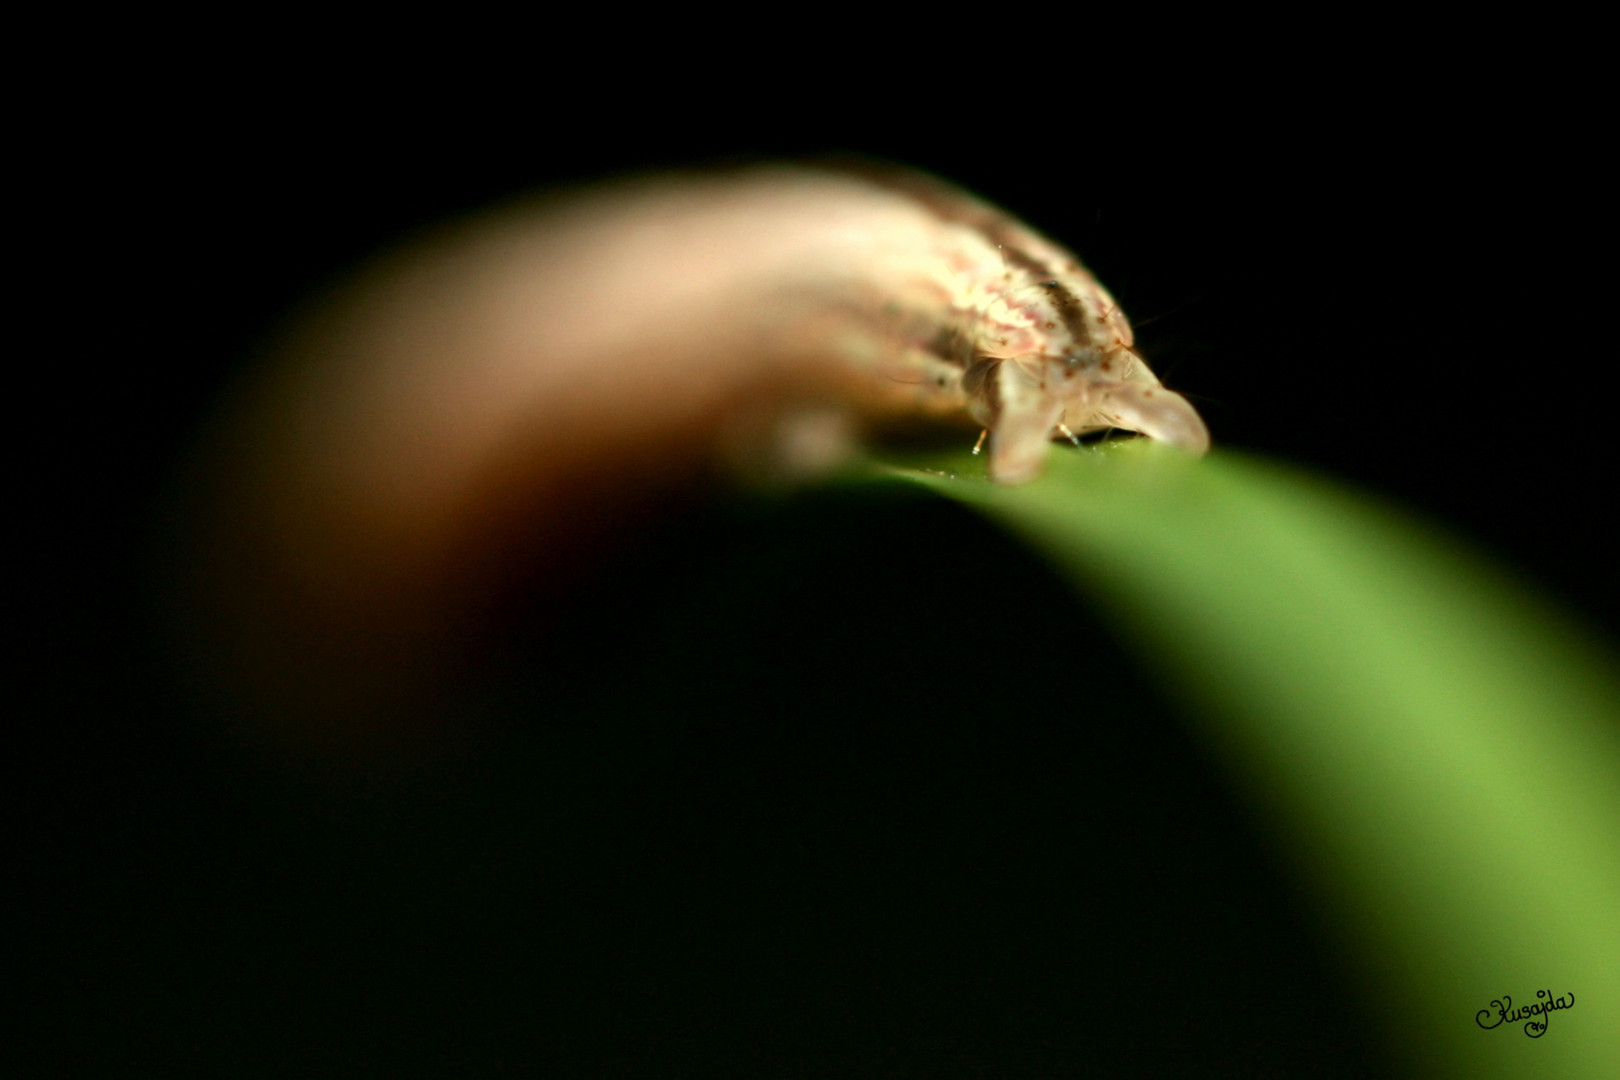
[{"x1": 885, "y1": 440, "x2": 1620, "y2": 1078}]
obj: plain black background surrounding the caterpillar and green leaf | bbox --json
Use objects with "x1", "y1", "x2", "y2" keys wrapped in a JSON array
[{"x1": 6, "y1": 39, "x2": 1620, "y2": 1075}]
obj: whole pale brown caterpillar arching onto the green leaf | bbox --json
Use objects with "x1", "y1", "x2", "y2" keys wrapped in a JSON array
[{"x1": 188, "y1": 168, "x2": 1207, "y2": 738}]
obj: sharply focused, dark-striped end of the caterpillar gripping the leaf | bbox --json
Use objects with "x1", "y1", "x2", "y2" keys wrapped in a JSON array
[{"x1": 790, "y1": 173, "x2": 1209, "y2": 484}]
